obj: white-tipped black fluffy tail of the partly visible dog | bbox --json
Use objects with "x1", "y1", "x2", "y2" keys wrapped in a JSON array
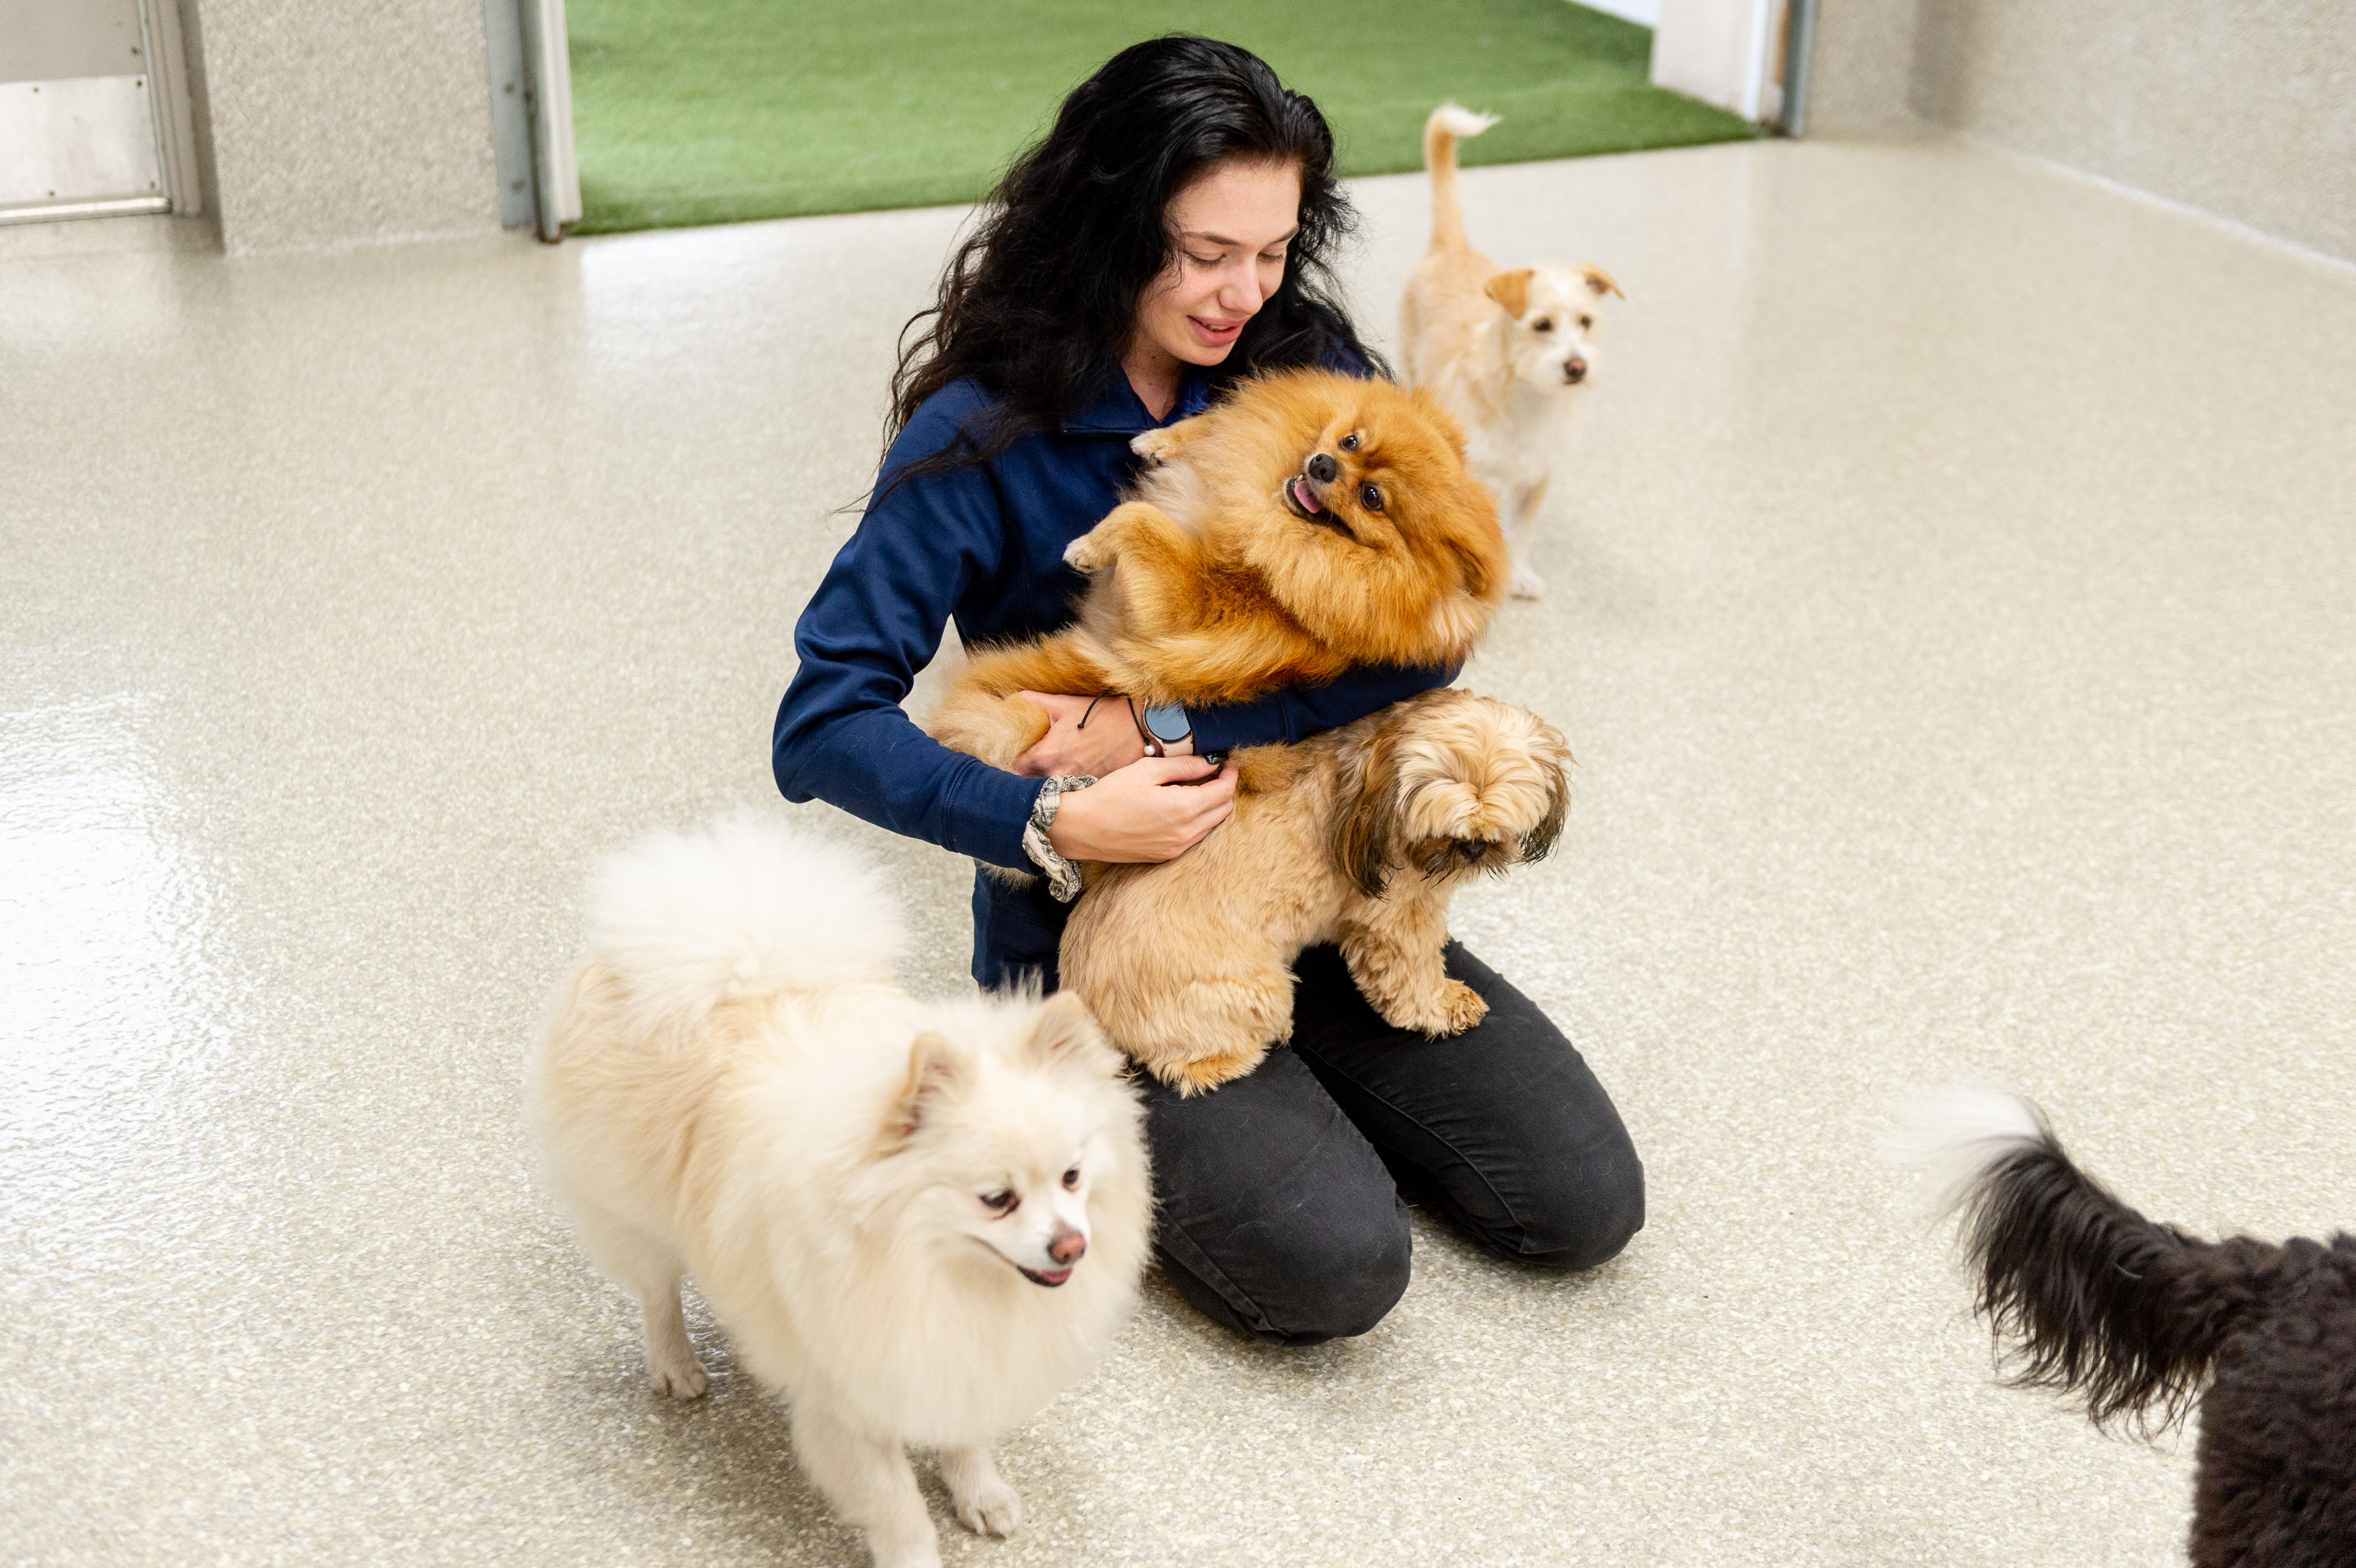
[{"x1": 1885, "y1": 1089, "x2": 2281, "y2": 1429}]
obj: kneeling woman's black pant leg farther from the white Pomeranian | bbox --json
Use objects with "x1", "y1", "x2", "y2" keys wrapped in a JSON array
[{"x1": 1291, "y1": 943, "x2": 1645, "y2": 1268}]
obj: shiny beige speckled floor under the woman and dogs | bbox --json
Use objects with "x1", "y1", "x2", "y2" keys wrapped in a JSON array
[{"x1": 0, "y1": 141, "x2": 2356, "y2": 1568}]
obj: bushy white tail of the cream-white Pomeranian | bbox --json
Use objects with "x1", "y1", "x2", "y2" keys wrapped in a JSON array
[{"x1": 589, "y1": 813, "x2": 907, "y2": 1023}]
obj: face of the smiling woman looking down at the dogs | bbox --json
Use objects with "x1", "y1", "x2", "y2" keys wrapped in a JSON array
[{"x1": 1131, "y1": 163, "x2": 1300, "y2": 365}]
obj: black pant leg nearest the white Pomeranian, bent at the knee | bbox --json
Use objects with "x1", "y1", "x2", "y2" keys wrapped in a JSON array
[{"x1": 1143, "y1": 1049, "x2": 1411, "y2": 1344}]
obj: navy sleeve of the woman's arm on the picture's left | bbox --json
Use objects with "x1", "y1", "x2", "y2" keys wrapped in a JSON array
[{"x1": 770, "y1": 394, "x2": 1041, "y2": 868}]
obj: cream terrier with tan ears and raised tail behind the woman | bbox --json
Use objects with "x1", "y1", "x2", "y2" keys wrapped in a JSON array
[{"x1": 1400, "y1": 104, "x2": 1621, "y2": 599}]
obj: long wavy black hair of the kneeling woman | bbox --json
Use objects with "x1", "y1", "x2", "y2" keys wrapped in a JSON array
[{"x1": 884, "y1": 35, "x2": 1388, "y2": 488}]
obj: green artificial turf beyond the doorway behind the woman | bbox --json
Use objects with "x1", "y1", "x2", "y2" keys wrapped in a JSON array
[{"x1": 568, "y1": 0, "x2": 1757, "y2": 233}]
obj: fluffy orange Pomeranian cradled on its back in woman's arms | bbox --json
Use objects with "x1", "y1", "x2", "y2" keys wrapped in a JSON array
[{"x1": 926, "y1": 370, "x2": 1510, "y2": 769}]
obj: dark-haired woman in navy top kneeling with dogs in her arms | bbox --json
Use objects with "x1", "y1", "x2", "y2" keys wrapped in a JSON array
[{"x1": 775, "y1": 38, "x2": 1645, "y2": 1344}]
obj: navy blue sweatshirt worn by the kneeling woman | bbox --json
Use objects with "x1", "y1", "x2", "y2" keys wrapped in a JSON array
[{"x1": 773, "y1": 375, "x2": 1453, "y2": 988}]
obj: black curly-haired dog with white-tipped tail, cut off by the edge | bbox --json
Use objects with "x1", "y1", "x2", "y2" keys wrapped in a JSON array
[{"x1": 1892, "y1": 1089, "x2": 2356, "y2": 1568}]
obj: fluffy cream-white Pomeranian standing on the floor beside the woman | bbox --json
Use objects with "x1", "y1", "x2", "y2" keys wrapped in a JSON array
[{"x1": 526, "y1": 821, "x2": 1152, "y2": 1568}]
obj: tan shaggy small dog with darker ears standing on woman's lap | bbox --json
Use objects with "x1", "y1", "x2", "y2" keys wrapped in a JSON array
[{"x1": 1060, "y1": 688, "x2": 1571, "y2": 1094}]
